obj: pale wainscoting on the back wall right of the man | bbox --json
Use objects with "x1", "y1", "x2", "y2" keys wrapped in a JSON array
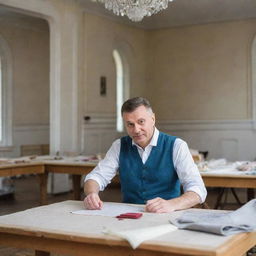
[{"x1": 158, "y1": 120, "x2": 256, "y2": 161}]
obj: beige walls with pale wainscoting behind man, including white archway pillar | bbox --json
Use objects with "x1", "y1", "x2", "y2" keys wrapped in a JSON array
[{"x1": 0, "y1": 0, "x2": 256, "y2": 160}]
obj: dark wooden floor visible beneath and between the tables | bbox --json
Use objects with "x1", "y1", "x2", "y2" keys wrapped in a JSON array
[{"x1": 0, "y1": 176, "x2": 253, "y2": 256}]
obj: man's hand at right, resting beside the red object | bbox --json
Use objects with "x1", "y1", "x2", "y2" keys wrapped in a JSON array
[{"x1": 145, "y1": 197, "x2": 175, "y2": 213}]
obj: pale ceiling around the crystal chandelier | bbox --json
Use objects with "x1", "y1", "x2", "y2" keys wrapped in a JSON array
[{"x1": 78, "y1": 0, "x2": 256, "y2": 29}]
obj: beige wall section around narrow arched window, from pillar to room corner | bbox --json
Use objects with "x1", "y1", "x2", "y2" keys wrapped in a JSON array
[{"x1": 82, "y1": 13, "x2": 148, "y2": 154}]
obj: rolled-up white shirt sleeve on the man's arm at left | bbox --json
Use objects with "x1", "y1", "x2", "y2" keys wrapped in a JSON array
[{"x1": 84, "y1": 139, "x2": 120, "y2": 191}]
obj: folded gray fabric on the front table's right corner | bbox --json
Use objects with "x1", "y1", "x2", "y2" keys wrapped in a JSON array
[{"x1": 170, "y1": 199, "x2": 256, "y2": 236}]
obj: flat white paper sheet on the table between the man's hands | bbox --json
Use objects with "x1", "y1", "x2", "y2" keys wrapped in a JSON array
[{"x1": 72, "y1": 203, "x2": 144, "y2": 217}]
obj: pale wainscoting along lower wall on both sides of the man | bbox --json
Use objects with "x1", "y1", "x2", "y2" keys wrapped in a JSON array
[{"x1": 83, "y1": 115, "x2": 256, "y2": 161}]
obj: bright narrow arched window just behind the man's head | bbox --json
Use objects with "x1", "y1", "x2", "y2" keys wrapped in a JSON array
[{"x1": 113, "y1": 50, "x2": 125, "y2": 132}]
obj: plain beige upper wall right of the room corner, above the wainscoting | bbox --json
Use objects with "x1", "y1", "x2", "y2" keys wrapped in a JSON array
[{"x1": 148, "y1": 19, "x2": 256, "y2": 120}]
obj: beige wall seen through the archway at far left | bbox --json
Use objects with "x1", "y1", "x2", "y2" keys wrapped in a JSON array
[{"x1": 0, "y1": 11, "x2": 50, "y2": 157}]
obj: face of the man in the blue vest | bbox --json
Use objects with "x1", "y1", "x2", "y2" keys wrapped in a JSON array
[{"x1": 123, "y1": 106, "x2": 155, "y2": 148}]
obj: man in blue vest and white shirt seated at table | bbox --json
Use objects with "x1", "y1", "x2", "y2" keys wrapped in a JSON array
[{"x1": 84, "y1": 97, "x2": 207, "y2": 213}]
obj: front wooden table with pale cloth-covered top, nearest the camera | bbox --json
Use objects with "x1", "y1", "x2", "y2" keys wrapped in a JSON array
[{"x1": 0, "y1": 201, "x2": 256, "y2": 256}]
